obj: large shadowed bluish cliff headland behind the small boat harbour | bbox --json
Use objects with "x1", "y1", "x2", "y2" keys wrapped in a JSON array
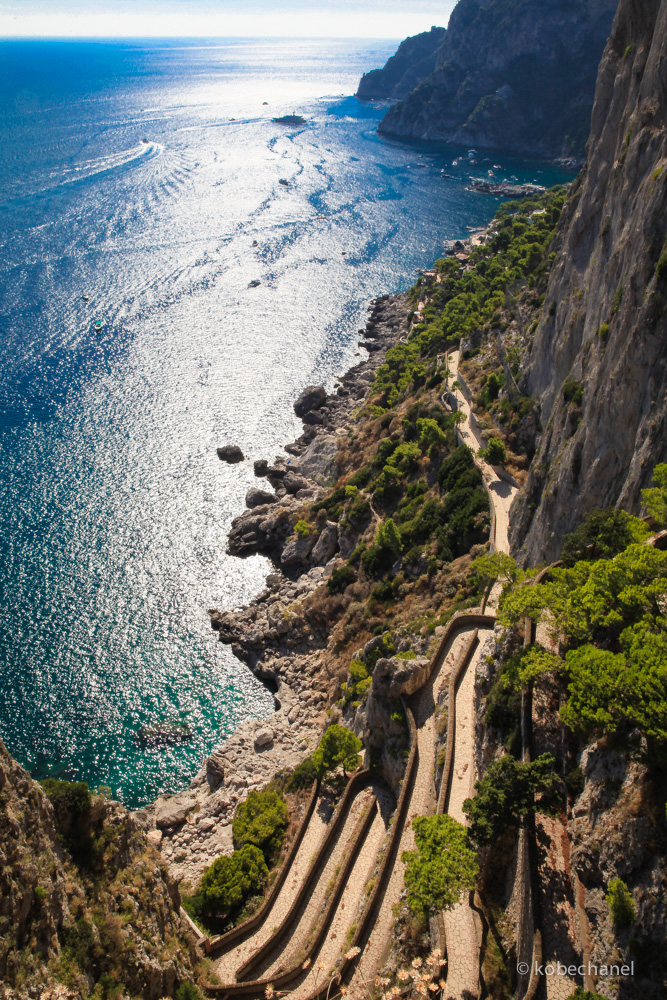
[{"x1": 379, "y1": 0, "x2": 616, "y2": 158}]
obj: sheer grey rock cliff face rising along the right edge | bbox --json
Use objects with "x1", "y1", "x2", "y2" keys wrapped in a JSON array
[{"x1": 512, "y1": 0, "x2": 667, "y2": 563}]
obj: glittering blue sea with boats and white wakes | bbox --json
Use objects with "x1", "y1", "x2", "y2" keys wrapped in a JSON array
[{"x1": 0, "y1": 40, "x2": 576, "y2": 806}]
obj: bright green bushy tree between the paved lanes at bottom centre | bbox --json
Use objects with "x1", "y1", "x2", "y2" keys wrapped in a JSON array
[{"x1": 401, "y1": 815, "x2": 479, "y2": 917}]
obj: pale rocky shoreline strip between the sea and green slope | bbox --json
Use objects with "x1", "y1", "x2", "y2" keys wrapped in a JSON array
[{"x1": 133, "y1": 293, "x2": 409, "y2": 886}]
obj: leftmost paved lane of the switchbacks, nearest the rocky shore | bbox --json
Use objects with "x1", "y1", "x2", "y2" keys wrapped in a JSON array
[{"x1": 213, "y1": 797, "x2": 328, "y2": 983}]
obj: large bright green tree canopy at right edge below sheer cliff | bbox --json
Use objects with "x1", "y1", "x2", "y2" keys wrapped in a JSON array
[{"x1": 499, "y1": 528, "x2": 667, "y2": 743}]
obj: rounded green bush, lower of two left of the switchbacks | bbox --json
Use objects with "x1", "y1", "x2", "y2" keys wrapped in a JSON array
[{"x1": 199, "y1": 840, "x2": 269, "y2": 917}]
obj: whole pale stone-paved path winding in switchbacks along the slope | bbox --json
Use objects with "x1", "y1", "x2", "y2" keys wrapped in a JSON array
[{"x1": 211, "y1": 351, "x2": 518, "y2": 1000}]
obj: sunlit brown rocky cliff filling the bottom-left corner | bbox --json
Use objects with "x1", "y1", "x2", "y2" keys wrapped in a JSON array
[{"x1": 0, "y1": 743, "x2": 194, "y2": 1000}]
